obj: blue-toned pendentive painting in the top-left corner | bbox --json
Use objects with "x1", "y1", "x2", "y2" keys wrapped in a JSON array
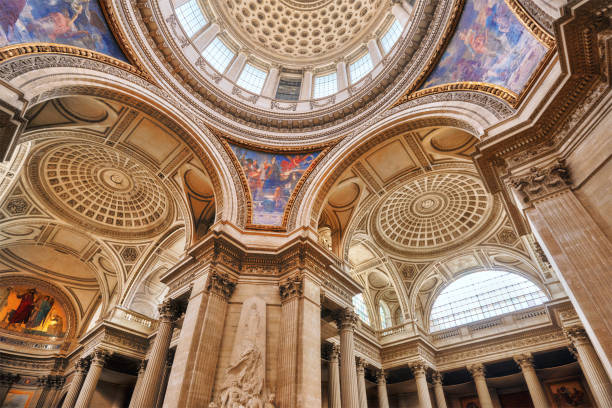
[{"x1": 0, "y1": 0, "x2": 127, "y2": 62}]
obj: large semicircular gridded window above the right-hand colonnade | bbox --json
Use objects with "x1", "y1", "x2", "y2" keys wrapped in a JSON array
[{"x1": 429, "y1": 271, "x2": 548, "y2": 331}]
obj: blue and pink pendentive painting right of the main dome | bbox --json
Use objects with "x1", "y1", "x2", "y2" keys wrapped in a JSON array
[{"x1": 423, "y1": 0, "x2": 547, "y2": 94}]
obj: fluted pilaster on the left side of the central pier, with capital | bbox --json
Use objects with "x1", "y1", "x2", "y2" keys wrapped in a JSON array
[{"x1": 183, "y1": 271, "x2": 236, "y2": 408}]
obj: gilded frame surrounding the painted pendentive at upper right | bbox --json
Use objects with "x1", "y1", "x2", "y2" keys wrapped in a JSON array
[{"x1": 389, "y1": 0, "x2": 556, "y2": 109}]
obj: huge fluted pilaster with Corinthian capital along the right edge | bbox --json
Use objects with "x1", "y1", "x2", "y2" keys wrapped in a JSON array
[{"x1": 509, "y1": 160, "x2": 612, "y2": 377}]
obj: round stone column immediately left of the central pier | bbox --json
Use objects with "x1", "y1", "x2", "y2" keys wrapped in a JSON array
[{"x1": 130, "y1": 299, "x2": 177, "y2": 408}]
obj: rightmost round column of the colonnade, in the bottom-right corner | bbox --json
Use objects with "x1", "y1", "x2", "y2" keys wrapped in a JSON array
[{"x1": 564, "y1": 327, "x2": 612, "y2": 408}]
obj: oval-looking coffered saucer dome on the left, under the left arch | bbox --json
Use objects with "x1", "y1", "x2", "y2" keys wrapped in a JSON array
[{"x1": 29, "y1": 143, "x2": 173, "y2": 237}]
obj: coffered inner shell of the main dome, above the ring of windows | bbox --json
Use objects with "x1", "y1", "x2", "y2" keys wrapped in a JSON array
[{"x1": 220, "y1": 0, "x2": 389, "y2": 64}]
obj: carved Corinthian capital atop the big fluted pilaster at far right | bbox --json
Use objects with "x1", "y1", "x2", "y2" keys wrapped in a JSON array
[{"x1": 509, "y1": 159, "x2": 571, "y2": 203}]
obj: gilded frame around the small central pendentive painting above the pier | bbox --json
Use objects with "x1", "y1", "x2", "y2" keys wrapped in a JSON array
[{"x1": 220, "y1": 138, "x2": 331, "y2": 232}]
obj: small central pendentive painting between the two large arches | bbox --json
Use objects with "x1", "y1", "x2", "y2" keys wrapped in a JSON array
[{"x1": 231, "y1": 145, "x2": 320, "y2": 227}]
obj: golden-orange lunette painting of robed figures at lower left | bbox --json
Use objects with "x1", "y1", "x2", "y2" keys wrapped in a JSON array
[{"x1": 0, "y1": 286, "x2": 67, "y2": 337}]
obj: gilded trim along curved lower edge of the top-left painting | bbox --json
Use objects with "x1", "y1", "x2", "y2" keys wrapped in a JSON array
[{"x1": 0, "y1": 43, "x2": 149, "y2": 80}]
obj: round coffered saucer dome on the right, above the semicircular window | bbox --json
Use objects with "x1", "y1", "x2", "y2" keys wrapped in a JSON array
[{"x1": 372, "y1": 173, "x2": 494, "y2": 255}]
